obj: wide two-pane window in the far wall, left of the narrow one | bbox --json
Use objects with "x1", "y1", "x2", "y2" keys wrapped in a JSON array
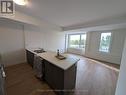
[{"x1": 68, "y1": 34, "x2": 86, "y2": 48}]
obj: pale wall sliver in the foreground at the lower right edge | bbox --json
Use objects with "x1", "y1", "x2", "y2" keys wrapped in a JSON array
[{"x1": 115, "y1": 35, "x2": 126, "y2": 95}]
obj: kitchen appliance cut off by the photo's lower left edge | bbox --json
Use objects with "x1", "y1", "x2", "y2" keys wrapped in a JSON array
[{"x1": 0, "y1": 63, "x2": 6, "y2": 95}]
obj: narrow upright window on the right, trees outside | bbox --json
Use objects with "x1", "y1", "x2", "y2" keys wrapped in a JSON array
[{"x1": 99, "y1": 32, "x2": 111, "y2": 52}]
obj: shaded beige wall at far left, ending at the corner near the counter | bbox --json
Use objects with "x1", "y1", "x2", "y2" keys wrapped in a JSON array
[{"x1": 0, "y1": 20, "x2": 25, "y2": 65}]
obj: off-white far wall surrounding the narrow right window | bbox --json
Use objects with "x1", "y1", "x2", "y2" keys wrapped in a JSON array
[{"x1": 85, "y1": 30, "x2": 126, "y2": 64}]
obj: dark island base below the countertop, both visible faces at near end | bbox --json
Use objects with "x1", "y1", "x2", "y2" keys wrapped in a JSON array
[{"x1": 43, "y1": 60, "x2": 76, "y2": 95}]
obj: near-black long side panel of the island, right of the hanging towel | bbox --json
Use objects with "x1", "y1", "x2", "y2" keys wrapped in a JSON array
[{"x1": 44, "y1": 60, "x2": 64, "y2": 90}]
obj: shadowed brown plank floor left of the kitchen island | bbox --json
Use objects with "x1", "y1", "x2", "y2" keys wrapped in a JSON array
[{"x1": 6, "y1": 63, "x2": 55, "y2": 95}]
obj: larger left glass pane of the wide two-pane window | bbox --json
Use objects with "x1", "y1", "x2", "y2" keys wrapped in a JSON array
[{"x1": 69, "y1": 35, "x2": 80, "y2": 48}]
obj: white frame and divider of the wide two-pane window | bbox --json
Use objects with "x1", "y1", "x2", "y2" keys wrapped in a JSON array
[{"x1": 67, "y1": 33, "x2": 87, "y2": 49}]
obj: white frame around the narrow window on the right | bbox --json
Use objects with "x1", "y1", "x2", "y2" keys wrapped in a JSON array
[{"x1": 98, "y1": 31, "x2": 113, "y2": 54}]
